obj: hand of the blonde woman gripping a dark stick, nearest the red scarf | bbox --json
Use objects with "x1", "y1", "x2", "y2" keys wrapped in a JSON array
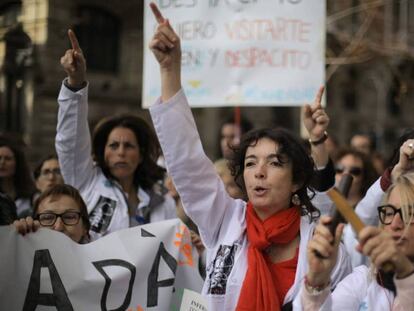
[{"x1": 307, "y1": 216, "x2": 344, "y2": 286}]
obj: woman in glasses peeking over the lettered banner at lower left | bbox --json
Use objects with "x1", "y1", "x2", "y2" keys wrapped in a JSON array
[{"x1": 13, "y1": 184, "x2": 90, "y2": 244}]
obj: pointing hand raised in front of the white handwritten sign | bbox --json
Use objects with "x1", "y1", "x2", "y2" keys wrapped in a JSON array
[{"x1": 149, "y1": 2, "x2": 181, "y2": 70}]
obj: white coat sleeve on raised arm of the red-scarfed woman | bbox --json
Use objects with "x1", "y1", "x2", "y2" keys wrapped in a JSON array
[{"x1": 150, "y1": 90, "x2": 245, "y2": 247}]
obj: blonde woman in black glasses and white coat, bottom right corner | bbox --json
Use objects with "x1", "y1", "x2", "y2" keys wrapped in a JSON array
[{"x1": 301, "y1": 173, "x2": 414, "y2": 311}]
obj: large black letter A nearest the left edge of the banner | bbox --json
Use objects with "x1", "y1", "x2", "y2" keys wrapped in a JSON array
[{"x1": 23, "y1": 249, "x2": 73, "y2": 311}]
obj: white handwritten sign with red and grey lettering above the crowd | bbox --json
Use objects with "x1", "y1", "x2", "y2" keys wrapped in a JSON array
[{"x1": 142, "y1": 0, "x2": 326, "y2": 107}]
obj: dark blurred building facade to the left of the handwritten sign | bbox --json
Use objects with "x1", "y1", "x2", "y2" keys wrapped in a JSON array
[{"x1": 0, "y1": 0, "x2": 148, "y2": 166}]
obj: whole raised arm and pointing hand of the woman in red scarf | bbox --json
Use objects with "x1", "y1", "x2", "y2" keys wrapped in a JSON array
[{"x1": 150, "y1": 4, "x2": 241, "y2": 247}]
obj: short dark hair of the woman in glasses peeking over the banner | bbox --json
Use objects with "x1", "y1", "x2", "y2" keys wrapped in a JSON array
[{"x1": 33, "y1": 184, "x2": 91, "y2": 235}]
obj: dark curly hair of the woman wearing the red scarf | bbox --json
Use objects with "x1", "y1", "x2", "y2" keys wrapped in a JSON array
[{"x1": 229, "y1": 128, "x2": 320, "y2": 220}]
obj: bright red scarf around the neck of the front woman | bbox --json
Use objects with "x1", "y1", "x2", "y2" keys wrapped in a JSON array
[{"x1": 236, "y1": 202, "x2": 300, "y2": 311}]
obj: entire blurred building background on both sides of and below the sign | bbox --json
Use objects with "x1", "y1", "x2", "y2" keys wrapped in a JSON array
[{"x1": 0, "y1": 0, "x2": 414, "y2": 166}]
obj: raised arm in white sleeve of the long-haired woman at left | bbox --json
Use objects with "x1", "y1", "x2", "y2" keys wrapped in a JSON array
[{"x1": 55, "y1": 30, "x2": 93, "y2": 191}]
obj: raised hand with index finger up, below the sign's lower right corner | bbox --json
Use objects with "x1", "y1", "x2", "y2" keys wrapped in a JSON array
[{"x1": 303, "y1": 86, "x2": 329, "y2": 141}]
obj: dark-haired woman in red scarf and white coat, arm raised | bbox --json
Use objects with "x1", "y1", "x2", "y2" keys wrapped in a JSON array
[{"x1": 150, "y1": 3, "x2": 350, "y2": 311}]
